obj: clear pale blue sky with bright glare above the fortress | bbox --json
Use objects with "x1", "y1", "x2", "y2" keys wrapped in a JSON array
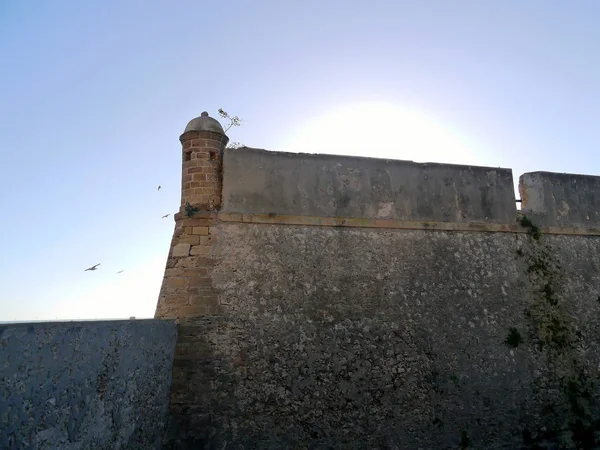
[{"x1": 0, "y1": 0, "x2": 600, "y2": 321}]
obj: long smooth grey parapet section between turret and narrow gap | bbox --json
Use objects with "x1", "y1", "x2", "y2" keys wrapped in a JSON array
[{"x1": 222, "y1": 147, "x2": 516, "y2": 223}]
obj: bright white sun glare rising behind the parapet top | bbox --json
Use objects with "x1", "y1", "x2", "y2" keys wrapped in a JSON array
[{"x1": 281, "y1": 102, "x2": 481, "y2": 165}]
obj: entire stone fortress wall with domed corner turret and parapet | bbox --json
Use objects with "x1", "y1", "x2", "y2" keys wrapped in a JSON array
[{"x1": 156, "y1": 110, "x2": 600, "y2": 449}]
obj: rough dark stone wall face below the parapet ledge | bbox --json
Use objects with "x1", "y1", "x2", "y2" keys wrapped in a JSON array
[{"x1": 170, "y1": 223, "x2": 600, "y2": 449}]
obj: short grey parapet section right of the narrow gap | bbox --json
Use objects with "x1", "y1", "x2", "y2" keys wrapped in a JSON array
[{"x1": 519, "y1": 172, "x2": 600, "y2": 227}]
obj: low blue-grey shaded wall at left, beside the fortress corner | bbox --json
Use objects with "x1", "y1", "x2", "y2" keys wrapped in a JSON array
[{"x1": 0, "y1": 320, "x2": 177, "y2": 450}]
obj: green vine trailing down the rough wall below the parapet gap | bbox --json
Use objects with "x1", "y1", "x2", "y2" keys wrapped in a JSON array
[{"x1": 512, "y1": 216, "x2": 600, "y2": 449}]
